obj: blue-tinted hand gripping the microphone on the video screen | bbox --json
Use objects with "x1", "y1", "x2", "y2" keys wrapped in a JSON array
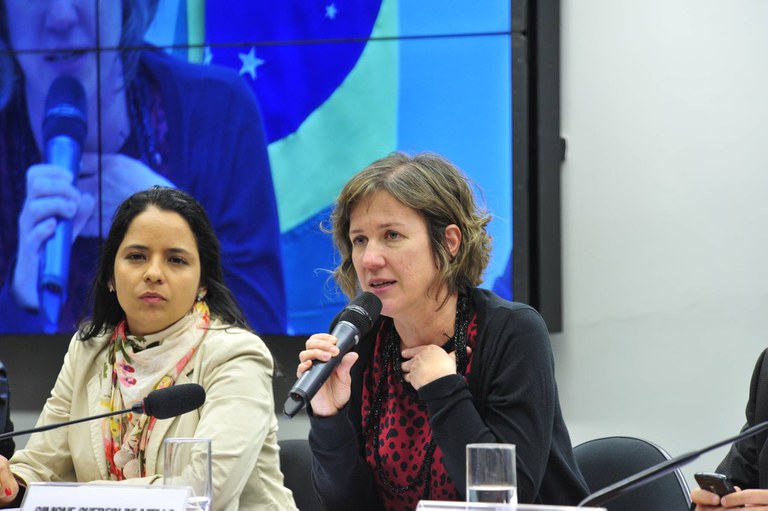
[{"x1": 12, "y1": 163, "x2": 95, "y2": 309}]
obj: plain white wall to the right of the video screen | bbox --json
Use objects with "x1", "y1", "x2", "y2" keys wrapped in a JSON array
[{"x1": 552, "y1": 0, "x2": 768, "y2": 481}]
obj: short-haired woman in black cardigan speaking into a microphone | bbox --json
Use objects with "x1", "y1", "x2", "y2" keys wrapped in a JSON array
[{"x1": 297, "y1": 153, "x2": 587, "y2": 510}]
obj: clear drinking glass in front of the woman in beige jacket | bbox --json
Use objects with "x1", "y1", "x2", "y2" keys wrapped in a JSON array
[{"x1": 163, "y1": 438, "x2": 213, "y2": 511}]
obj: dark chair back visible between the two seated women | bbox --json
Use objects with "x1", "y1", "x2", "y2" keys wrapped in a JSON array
[{"x1": 278, "y1": 438, "x2": 323, "y2": 511}]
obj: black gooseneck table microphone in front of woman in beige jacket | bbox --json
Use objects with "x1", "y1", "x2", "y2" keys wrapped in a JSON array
[{"x1": 0, "y1": 383, "x2": 205, "y2": 440}]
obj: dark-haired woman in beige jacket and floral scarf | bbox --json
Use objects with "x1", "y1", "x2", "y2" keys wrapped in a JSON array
[{"x1": 0, "y1": 187, "x2": 295, "y2": 510}]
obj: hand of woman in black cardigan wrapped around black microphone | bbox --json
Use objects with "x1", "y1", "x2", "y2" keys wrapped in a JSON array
[{"x1": 296, "y1": 334, "x2": 358, "y2": 417}]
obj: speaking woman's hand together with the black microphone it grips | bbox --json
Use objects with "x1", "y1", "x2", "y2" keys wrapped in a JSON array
[{"x1": 283, "y1": 292, "x2": 381, "y2": 417}]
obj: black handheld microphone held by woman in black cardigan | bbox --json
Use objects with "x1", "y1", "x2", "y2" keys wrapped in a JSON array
[{"x1": 283, "y1": 291, "x2": 381, "y2": 418}]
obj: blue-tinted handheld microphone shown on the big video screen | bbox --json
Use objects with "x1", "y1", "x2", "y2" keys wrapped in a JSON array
[{"x1": 38, "y1": 76, "x2": 88, "y2": 334}]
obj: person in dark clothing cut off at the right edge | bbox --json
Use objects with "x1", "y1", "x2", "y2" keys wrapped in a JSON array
[{"x1": 691, "y1": 350, "x2": 768, "y2": 511}]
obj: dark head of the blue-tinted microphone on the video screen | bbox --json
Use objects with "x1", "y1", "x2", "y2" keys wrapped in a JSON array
[{"x1": 43, "y1": 76, "x2": 88, "y2": 145}]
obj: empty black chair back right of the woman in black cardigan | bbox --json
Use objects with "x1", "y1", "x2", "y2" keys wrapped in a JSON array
[{"x1": 573, "y1": 436, "x2": 691, "y2": 511}]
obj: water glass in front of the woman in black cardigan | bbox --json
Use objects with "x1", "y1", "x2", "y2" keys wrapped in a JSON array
[{"x1": 467, "y1": 444, "x2": 517, "y2": 504}]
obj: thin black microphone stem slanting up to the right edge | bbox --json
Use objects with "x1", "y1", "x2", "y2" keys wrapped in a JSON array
[{"x1": 577, "y1": 421, "x2": 768, "y2": 507}]
